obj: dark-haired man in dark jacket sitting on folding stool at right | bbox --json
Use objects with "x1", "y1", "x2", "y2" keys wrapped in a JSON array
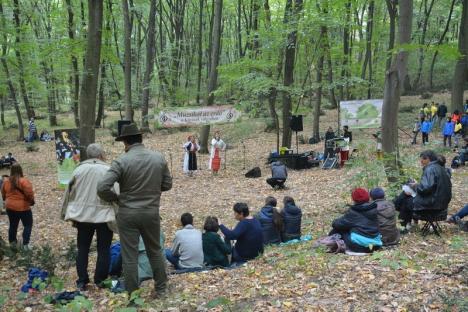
[{"x1": 410, "y1": 150, "x2": 452, "y2": 219}]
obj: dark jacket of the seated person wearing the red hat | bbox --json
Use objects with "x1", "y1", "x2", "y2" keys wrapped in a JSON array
[{"x1": 332, "y1": 202, "x2": 379, "y2": 238}]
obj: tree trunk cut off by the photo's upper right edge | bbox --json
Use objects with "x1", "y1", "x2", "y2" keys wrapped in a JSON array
[{"x1": 451, "y1": 0, "x2": 468, "y2": 112}]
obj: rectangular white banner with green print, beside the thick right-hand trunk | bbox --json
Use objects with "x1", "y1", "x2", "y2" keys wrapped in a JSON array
[{"x1": 340, "y1": 100, "x2": 383, "y2": 128}]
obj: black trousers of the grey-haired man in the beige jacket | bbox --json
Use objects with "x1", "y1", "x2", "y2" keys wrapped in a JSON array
[{"x1": 75, "y1": 222, "x2": 113, "y2": 284}]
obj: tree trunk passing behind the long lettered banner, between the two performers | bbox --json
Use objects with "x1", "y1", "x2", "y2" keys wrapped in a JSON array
[{"x1": 200, "y1": 0, "x2": 223, "y2": 153}]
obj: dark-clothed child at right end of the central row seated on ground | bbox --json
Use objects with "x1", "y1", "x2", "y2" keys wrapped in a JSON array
[{"x1": 280, "y1": 196, "x2": 302, "y2": 242}]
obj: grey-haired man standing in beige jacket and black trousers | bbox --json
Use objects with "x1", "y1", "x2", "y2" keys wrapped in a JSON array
[{"x1": 62, "y1": 143, "x2": 117, "y2": 290}]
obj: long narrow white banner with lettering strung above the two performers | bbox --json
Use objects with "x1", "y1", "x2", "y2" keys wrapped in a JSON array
[{"x1": 159, "y1": 106, "x2": 241, "y2": 128}]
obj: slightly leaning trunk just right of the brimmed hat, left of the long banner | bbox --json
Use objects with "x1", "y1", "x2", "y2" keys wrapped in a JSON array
[{"x1": 141, "y1": 0, "x2": 156, "y2": 131}]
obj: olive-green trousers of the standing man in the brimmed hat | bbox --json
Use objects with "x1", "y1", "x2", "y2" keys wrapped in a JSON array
[{"x1": 117, "y1": 209, "x2": 167, "y2": 294}]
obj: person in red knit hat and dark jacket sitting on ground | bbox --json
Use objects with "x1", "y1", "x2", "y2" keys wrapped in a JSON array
[{"x1": 329, "y1": 188, "x2": 383, "y2": 253}]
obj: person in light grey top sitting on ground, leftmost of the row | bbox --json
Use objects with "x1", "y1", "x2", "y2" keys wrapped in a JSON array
[{"x1": 165, "y1": 212, "x2": 203, "y2": 270}]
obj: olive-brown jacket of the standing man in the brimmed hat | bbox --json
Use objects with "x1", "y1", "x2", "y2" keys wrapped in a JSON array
[{"x1": 97, "y1": 143, "x2": 172, "y2": 213}]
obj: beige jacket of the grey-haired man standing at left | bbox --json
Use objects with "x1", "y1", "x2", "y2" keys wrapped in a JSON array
[{"x1": 62, "y1": 159, "x2": 118, "y2": 227}]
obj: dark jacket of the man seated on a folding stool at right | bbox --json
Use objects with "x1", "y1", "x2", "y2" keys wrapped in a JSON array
[{"x1": 414, "y1": 161, "x2": 452, "y2": 212}]
